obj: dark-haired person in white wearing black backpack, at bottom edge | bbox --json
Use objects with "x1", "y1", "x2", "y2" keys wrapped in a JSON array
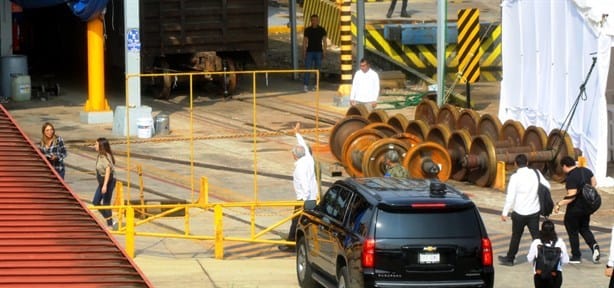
[{"x1": 527, "y1": 220, "x2": 569, "y2": 288}]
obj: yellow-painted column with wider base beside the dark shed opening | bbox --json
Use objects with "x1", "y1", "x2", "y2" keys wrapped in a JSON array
[{"x1": 85, "y1": 18, "x2": 110, "y2": 112}]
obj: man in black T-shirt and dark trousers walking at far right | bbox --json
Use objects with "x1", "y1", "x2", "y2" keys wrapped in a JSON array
[{"x1": 554, "y1": 156, "x2": 601, "y2": 263}]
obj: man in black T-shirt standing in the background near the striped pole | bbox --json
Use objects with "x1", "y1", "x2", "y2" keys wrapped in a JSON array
[{"x1": 303, "y1": 14, "x2": 326, "y2": 92}]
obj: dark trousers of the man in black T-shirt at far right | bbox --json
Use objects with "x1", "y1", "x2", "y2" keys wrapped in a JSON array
[{"x1": 563, "y1": 209, "x2": 597, "y2": 258}]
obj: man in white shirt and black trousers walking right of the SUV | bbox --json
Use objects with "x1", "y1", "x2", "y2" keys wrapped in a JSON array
[{"x1": 499, "y1": 154, "x2": 550, "y2": 266}]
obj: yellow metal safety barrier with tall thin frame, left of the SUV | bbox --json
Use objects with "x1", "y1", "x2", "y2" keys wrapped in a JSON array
[{"x1": 90, "y1": 70, "x2": 328, "y2": 259}]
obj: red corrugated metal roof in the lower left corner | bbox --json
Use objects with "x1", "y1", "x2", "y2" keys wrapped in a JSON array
[{"x1": 0, "y1": 105, "x2": 152, "y2": 287}]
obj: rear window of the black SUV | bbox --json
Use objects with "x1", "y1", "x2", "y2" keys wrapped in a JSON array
[{"x1": 375, "y1": 208, "x2": 480, "y2": 238}]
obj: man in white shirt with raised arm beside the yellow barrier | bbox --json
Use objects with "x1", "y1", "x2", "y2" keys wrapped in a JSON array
[{"x1": 278, "y1": 123, "x2": 318, "y2": 251}]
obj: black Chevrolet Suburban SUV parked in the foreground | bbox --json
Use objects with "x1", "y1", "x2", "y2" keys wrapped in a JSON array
[{"x1": 296, "y1": 178, "x2": 495, "y2": 287}]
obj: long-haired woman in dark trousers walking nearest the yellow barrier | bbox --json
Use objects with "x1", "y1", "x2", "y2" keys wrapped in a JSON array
[{"x1": 92, "y1": 138, "x2": 115, "y2": 227}]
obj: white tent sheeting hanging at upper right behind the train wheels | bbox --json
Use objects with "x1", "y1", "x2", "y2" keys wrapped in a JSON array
[{"x1": 499, "y1": 0, "x2": 614, "y2": 182}]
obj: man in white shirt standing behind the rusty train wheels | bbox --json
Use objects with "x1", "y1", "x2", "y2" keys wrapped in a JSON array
[{"x1": 350, "y1": 58, "x2": 379, "y2": 108}]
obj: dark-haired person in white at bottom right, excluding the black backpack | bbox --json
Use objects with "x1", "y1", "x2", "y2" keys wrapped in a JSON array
[{"x1": 527, "y1": 220, "x2": 569, "y2": 288}]
